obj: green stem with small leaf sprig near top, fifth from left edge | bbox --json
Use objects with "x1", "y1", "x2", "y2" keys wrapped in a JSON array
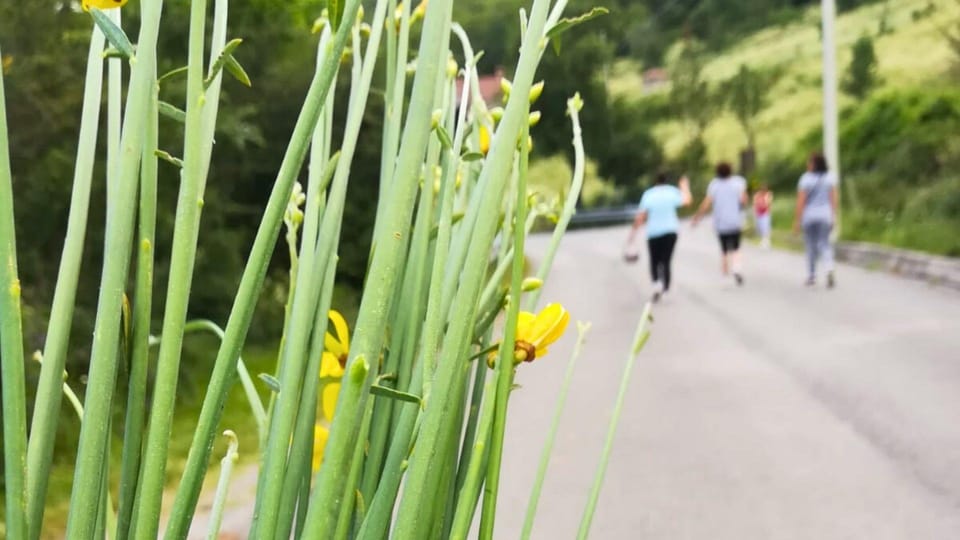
[{"x1": 133, "y1": 0, "x2": 219, "y2": 540}]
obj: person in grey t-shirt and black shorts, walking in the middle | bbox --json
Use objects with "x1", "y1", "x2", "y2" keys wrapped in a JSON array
[{"x1": 693, "y1": 162, "x2": 747, "y2": 285}]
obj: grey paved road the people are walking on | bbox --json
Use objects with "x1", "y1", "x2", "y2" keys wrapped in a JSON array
[{"x1": 496, "y1": 221, "x2": 960, "y2": 540}]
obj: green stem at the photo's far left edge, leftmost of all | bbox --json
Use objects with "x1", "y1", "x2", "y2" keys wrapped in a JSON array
[{"x1": 0, "y1": 42, "x2": 29, "y2": 538}]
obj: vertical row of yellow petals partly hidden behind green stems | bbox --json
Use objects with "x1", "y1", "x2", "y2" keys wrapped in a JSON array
[{"x1": 313, "y1": 310, "x2": 350, "y2": 472}]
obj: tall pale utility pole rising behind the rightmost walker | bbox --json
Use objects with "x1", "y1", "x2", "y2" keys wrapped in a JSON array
[{"x1": 820, "y1": 0, "x2": 840, "y2": 234}]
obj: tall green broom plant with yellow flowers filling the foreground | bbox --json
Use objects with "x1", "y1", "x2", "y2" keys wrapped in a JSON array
[{"x1": 0, "y1": 0, "x2": 652, "y2": 540}]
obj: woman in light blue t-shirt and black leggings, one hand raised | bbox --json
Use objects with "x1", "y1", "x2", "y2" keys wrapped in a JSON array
[{"x1": 627, "y1": 173, "x2": 693, "y2": 302}]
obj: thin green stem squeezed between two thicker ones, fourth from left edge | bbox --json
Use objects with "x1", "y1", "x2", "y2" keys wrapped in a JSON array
[{"x1": 115, "y1": 70, "x2": 160, "y2": 539}]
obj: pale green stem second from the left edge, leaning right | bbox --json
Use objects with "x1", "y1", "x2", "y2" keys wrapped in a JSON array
[{"x1": 26, "y1": 25, "x2": 104, "y2": 539}]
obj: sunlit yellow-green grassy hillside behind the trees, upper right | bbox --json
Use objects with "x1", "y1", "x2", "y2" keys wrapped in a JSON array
[{"x1": 608, "y1": 0, "x2": 960, "y2": 165}]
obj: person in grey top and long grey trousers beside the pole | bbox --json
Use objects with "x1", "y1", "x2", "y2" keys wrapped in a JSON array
[{"x1": 793, "y1": 153, "x2": 837, "y2": 289}]
